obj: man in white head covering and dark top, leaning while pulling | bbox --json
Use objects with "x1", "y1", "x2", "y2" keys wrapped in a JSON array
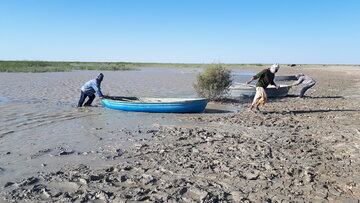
[{"x1": 246, "y1": 64, "x2": 280, "y2": 111}]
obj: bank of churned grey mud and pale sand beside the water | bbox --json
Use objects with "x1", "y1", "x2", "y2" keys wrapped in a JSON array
[{"x1": 0, "y1": 66, "x2": 360, "y2": 202}]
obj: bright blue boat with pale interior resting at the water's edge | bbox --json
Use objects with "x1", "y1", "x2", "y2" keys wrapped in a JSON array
[{"x1": 101, "y1": 97, "x2": 208, "y2": 113}]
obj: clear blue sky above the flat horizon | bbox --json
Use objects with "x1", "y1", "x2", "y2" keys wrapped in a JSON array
[{"x1": 0, "y1": 0, "x2": 360, "y2": 64}]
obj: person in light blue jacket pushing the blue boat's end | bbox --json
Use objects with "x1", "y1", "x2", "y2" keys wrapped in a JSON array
[{"x1": 77, "y1": 73, "x2": 104, "y2": 107}]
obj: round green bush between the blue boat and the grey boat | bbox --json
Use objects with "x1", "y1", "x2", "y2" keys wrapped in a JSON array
[{"x1": 194, "y1": 64, "x2": 232, "y2": 100}]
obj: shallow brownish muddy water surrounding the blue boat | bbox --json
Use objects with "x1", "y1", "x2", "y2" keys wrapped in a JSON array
[{"x1": 0, "y1": 68, "x2": 252, "y2": 182}]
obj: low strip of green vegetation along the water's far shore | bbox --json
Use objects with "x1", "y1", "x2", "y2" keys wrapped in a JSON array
[{"x1": 0, "y1": 61, "x2": 264, "y2": 72}]
